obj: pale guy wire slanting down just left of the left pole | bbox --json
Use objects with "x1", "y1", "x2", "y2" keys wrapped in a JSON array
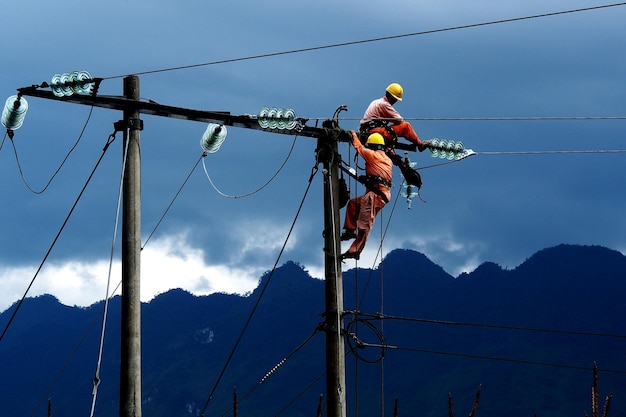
[{"x1": 89, "y1": 128, "x2": 130, "y2": 417}]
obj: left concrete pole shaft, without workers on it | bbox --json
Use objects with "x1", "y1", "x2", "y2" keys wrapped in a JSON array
[{"x1": 120, "y1": 76, "x2": 141, "y2": 417}]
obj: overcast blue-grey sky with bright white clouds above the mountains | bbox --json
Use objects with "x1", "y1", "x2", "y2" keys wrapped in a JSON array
[{"x1": 0, "y1": 0, "x2": 626, "y2": 310}]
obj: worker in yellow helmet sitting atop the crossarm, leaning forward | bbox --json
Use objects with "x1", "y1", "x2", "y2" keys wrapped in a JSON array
[{"x1": 359, "y1": 83, "x2": 427, "y2": 152}]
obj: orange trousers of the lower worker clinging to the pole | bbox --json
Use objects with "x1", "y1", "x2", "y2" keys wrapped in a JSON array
[{"x1": 343, "y1": 191, "x2": 387, "y2": 254}]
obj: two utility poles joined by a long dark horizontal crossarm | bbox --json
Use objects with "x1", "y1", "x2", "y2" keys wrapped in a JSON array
[{"x1": 18, "y1": 76, "x2": 346, "y2": 417}]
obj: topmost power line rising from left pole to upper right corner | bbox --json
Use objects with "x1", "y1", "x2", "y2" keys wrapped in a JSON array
[{"x1": 104, "y1": 2, "x2": 626, "y2": 79}]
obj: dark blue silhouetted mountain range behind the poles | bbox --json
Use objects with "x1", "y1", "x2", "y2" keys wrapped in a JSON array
[{"x1": 0, "y1": 245, "x2": 626, "y2": 417}]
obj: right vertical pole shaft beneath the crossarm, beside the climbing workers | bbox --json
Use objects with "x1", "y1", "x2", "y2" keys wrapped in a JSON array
[{"x1": 318, "y1": 132, "x2": 346, "y2": 417}]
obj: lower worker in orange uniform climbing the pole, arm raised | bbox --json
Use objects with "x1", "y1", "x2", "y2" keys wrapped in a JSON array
[{"x1": 341, "y1": 131, "x2": 393, "y2": 259}]
